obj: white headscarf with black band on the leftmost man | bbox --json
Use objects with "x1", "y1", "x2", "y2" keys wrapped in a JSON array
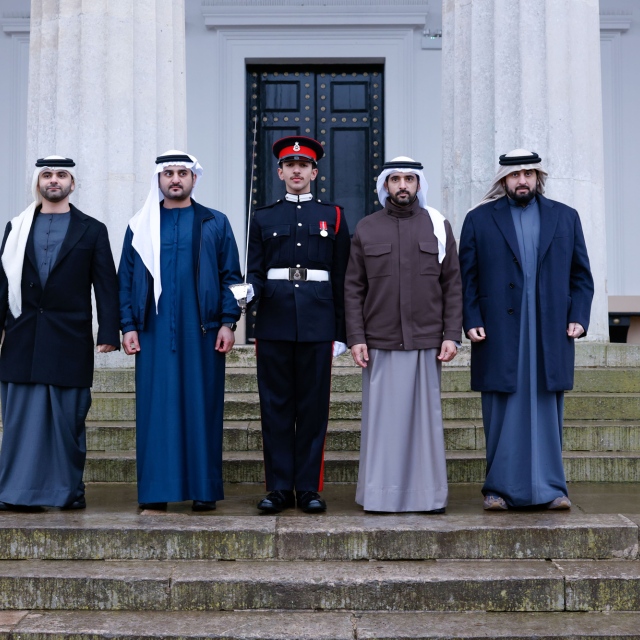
[{"x1": 2, "y1": 156, "x2": 76, "y2": 318}]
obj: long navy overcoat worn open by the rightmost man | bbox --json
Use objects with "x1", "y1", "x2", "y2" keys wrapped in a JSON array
[{"x1": 460, "y1": 195, "x2": 593, "y2": 393}]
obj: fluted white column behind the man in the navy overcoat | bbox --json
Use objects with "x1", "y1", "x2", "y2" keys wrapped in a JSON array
[{"x1": 442, "y1": 0, "x2": 609, "y2": 340}]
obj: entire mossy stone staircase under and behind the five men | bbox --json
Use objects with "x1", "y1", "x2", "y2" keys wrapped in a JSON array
[{"x1": 0, "y1": 344, "x2": 640, "y2": 640}]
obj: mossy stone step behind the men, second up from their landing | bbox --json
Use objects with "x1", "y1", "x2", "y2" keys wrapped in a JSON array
[{"x1": 72, "y1": 420, "x2": 640, "y2": 451}]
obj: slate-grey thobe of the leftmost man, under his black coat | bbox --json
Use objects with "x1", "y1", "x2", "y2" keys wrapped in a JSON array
[{"x1": 0, "y1": 213, "x2": 91, "y2": 507}]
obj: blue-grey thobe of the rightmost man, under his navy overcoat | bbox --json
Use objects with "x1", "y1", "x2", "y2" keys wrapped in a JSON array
[{"x1": 482, "y1": 198, "x2": 567, "y2": 507}]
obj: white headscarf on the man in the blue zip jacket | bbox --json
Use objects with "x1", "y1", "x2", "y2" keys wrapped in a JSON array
[{"x1": 129, "y1": 149, "x2": 203, "y2": 313}]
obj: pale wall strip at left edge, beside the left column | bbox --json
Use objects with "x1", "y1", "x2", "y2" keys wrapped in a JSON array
[{"x1": 0, "y1": 0, "x2": 30, "y2": 232}]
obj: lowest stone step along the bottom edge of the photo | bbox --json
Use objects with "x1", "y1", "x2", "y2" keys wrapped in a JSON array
[{"x1": 0, "y1": 611, "x2": 640, "y2": 640}]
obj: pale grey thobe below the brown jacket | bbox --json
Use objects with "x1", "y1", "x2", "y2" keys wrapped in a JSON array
[{"x1": 356, "y1": 349, "x2": 448, "y2": 512}]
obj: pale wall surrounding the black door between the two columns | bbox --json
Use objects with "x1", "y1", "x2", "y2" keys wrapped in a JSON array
[{"x1": 186, "y1": 0, "x2": 441, "y2": 247}]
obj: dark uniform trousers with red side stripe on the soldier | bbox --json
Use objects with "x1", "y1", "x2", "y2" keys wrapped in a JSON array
[{"x1": 256, "y1": 340, "x2": 333, "y2": 491}]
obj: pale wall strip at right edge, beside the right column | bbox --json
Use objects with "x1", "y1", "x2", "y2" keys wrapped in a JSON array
[{"x1": 600, "y1": 0, "x2": 640, "y2": 296}]
